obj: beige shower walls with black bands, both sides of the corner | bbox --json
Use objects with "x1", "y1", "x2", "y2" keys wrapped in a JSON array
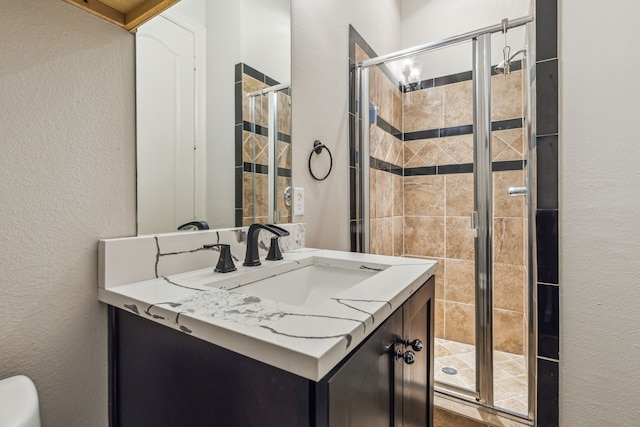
[{"x1": 355, "y1": 30, "x2": 526, "y2": 354}]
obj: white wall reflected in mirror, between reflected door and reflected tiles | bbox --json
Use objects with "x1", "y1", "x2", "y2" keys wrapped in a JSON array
[{"x1": 206, "y1": 0, "x2": 291, "y2": 228}]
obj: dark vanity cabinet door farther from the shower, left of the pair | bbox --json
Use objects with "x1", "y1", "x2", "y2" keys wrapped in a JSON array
[{"x1": 328, "y1": 309, "x2": 402, "y2": 427}]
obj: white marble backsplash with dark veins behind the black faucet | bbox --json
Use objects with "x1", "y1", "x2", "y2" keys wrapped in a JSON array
[{"x1": 98, "y1": 224, "x2": 305, "y2": 289}]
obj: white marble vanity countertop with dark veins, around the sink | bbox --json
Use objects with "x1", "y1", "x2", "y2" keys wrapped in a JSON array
[{"x1": 98, "y1": 248, "x2": 437, "y2": 381}]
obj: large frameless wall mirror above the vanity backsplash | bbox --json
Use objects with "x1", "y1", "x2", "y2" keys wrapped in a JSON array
[{"x1": 136, "y1": 0, "x2": 292, "y2": 234}]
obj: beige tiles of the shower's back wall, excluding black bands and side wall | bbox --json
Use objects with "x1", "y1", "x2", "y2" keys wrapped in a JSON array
[{"x1": 403, "y1": 71, "x2": 526, "y2": 354}]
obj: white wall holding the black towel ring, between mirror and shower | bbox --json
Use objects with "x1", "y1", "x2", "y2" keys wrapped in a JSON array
[{"x1": 292, "y1": 0, "x2": 400, "y2": 250}]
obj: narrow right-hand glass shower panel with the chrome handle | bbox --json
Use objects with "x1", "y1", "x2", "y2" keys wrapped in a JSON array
[{"x1": 491, "y1": 26, "x2": 533, "y2": 414}]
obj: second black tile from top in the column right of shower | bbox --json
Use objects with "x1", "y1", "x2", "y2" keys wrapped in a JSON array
[{"x1": 536, "y1": 59, "x2": 558, "y2": 135}]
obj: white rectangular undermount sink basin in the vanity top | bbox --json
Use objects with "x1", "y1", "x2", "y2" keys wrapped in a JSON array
[{"x1": 220, "y1": 257, "x2": 387, "y2": 307}]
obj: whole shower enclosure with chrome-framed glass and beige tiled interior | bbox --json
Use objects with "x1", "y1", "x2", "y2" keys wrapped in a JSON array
[{"x1": 351, "y1": 17, "x2": 536, "y2": 418}]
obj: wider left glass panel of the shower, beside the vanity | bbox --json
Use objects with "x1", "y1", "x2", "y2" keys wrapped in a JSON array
[{"x1": 361, "y1": 41, "x2": 477, "y2": 398}]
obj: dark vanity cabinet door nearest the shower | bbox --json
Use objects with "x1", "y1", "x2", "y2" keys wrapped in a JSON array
[{"x1": 398, "y1": 277, "x2": 435, "y2": 427}]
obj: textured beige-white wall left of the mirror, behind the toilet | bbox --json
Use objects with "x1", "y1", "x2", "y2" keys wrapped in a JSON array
[{"x1": 0, "y1": 0, "x2": 135, "y2": 426}]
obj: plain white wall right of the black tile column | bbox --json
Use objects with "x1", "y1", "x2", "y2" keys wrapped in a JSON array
[{"x1": 559, "y1": 0, "x2": 640, "y2": 426}]
